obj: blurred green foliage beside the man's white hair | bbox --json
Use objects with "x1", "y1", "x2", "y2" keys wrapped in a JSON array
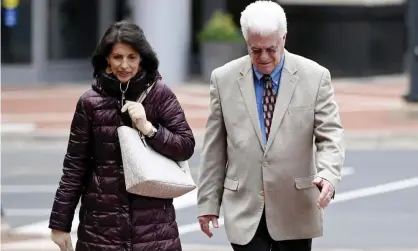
[{"x1": 198, "y1": 11, "x2": 243, "y2": 42}]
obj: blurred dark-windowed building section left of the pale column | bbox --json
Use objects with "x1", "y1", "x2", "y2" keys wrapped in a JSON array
[{"x1": 1, "y1": 0, "x2": 130, "y2": 85}]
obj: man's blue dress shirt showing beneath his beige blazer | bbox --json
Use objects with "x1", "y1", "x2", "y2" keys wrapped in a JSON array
[{"x1": 253, "y1": 56, "x2": 284, "y2": 144}]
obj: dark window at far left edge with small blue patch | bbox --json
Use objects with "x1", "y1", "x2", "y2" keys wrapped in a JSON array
[{"x1": 1, "y1": 0, "x2": 33, "y2": 64}]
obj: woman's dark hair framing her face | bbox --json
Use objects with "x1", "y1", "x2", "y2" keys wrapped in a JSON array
[{"x1": 91, "y1": 21, "x2": 159, "y2": 79}]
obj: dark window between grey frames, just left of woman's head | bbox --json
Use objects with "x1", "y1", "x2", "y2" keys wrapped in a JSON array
[{"x1": 48, "y1": 0, "x2": 99, "y2": 60}]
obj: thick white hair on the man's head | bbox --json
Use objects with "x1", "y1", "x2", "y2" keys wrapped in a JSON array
[{"x1": 240, "y1": 0, "x2": 287, "y2": 40}]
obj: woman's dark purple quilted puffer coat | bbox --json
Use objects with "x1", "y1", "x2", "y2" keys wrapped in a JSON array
[{"x1": 49, "y1": 73, "x2": 195, "y2": 251}]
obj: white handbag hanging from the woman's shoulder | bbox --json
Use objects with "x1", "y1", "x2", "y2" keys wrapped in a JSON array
[{"x1": 117, "y1": 84, "x2": 196, "y2": 199}]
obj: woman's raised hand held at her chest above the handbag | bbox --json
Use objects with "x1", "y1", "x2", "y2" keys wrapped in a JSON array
[{"x1": 122, "y1": 101, "x2": 153, "y2": 135}]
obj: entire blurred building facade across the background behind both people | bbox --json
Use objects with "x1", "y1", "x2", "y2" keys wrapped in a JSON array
[{"x1": 1, "y1": 0, "x2": 406, "y2": 85}]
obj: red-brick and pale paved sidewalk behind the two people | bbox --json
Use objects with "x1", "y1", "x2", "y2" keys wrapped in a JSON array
[{"x1": 1, "y1": 76, "x2": 418, "y2": 147}]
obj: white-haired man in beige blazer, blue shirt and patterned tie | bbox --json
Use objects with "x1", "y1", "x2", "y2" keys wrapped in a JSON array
[{"x1": 198, "y1": 1, "x2": 345, "y2": 251}]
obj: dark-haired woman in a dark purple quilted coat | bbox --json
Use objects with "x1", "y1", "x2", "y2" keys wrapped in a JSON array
[{"x1": 49, "y1": 21, "x2": 195, "y2": 251}]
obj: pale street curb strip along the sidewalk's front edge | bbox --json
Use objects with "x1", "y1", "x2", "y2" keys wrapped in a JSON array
[{"x1": 1, "y1": 130, "x2": 418, "y2": 149}]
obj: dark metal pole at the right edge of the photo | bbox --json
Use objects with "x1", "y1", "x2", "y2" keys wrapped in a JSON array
[{"x1": 404, "y1": 0, "x2": 418, "y2": 103}]
